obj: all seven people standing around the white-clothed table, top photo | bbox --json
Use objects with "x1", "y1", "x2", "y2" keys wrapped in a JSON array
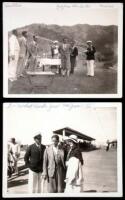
[{"x1": 8, "y1": 30, "x2": 96, "y2": 81}]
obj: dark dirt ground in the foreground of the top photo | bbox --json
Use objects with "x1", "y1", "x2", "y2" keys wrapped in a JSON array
[{"x1": 8, "y1": 60, "x2": 117, "y2": 94}]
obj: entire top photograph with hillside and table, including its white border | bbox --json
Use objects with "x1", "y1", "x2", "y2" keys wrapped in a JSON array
[{"x1": 3, "y1": 2, "x2": 123, "y2": 98}]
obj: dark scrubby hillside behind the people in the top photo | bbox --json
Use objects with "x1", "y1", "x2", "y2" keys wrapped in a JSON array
[{"x1": 11, "y1": 24, "x2": 118, "y2": 62}]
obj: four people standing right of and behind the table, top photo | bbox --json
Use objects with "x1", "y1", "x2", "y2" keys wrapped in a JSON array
[{"x1": 51, "y1": 38, "x2": 96, "y2": 77}]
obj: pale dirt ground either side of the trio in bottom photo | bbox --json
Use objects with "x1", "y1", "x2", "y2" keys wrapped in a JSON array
[{"x1": 7, "y1": 149, "x2": 117, "y2": 194}]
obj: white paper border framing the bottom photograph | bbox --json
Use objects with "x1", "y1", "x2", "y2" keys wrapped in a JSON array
[{"x1": 2, "y1": 102, "x2": 123, "y2": 198}]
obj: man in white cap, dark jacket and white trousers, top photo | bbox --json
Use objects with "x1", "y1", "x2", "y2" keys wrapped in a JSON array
[{"x1": 84, "y1": 40, "x2": 96, "y2": 77}]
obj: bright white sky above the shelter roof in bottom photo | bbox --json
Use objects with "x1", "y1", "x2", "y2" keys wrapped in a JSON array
[{"x1": 4, "y1": 103, "x2": 117, "y2": 144}]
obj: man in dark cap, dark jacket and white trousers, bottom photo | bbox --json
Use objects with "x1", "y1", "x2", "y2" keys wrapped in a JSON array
[{"x1": 24, "y1": 134, "x2": 45, "y2": 193}]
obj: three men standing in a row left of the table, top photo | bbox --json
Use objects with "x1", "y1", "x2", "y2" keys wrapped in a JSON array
[{"x1": 8, "y1": 30, "x2": 38, "y2": 82}]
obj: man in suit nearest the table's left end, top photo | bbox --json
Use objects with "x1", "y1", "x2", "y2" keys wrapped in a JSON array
[{"x1": 28, "y1": 35, "x2": 39, "y2": 71}]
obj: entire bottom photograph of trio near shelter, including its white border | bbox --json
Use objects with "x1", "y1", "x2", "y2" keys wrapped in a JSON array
[{"x1": 2, "y1": 102, "x2": 122, "y2": 197}]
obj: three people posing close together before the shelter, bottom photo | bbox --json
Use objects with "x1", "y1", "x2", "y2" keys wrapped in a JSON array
[{"x1": 24, "y1": 134, "x2": 83, "y2": 193}]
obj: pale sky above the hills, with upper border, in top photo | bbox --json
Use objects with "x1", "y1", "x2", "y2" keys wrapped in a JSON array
[{"x1": 3, "y1": 2, "x2": 122, "y2": 30}]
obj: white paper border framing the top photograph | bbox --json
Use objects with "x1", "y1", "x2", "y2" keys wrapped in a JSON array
[{"x1": 3, "y1": 2, "x2": 123, "y2": 98}]
